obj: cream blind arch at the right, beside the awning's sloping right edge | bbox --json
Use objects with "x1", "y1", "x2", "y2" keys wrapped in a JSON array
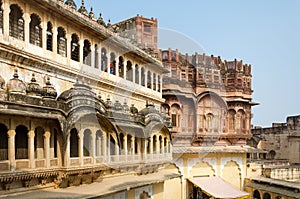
[{"x1": 222, "y1": 160, "x2": 242, "y2": 189}]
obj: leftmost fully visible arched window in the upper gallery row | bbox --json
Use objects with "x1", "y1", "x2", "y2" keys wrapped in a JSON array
[{"x1": 9, "y1": 4, "x2": 24, "y2": 41}]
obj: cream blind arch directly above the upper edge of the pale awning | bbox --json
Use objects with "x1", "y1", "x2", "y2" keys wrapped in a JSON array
[{"x1": 190, "y1": 161, "x2": 215, "y2": 177}]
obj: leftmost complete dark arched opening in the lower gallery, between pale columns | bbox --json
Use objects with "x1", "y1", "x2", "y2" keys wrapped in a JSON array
[{"x1": 15, "y1": 125, "x2": 28, "y2": 159}]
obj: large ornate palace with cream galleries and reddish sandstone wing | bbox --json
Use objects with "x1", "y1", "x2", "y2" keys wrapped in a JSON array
[{"x1": 0, "y1": 0, "x2": 256, "y2": 199}]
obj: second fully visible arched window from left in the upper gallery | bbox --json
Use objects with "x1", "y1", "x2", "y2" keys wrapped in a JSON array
[{"x1": 29, "y1": 14, "x2": 42, "y2": 47}]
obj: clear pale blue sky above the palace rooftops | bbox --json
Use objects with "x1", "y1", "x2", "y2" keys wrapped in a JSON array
[{"x1": 75, "y1": 0, "x2": 300, "y2": 126}]
